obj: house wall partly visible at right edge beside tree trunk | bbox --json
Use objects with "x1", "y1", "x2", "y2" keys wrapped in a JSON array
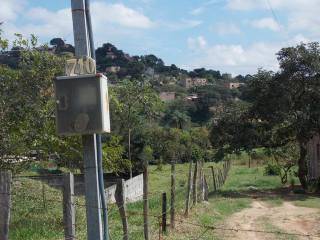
[{"x1": 307, "y1": 134, "x2": 320, "y2": 180}]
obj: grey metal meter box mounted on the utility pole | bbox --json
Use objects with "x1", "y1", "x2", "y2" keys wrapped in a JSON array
[{"x1": 54, "y1": 74, "x2": 110, "y2": 136}]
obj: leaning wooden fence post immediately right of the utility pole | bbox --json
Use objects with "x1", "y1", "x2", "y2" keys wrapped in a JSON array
[{"x1": 115, "y1": 179, "x2": 129, "y2": 240}]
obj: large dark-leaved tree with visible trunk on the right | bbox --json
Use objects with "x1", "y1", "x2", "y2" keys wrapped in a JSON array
[{"x1": 211, "y1": 43, "x2": 320, "y2": 188}]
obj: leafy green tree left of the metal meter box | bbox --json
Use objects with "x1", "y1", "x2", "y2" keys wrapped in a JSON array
[{"x1": 0, "y1": 34, "x2": 82, "y2": 172}]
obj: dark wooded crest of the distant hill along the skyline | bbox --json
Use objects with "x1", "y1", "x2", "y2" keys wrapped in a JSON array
[{"x1": 0, "y1": 38, "x2": 250, "y2": 86}]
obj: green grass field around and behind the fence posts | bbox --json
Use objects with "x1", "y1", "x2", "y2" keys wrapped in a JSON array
[{"x1": 10, "y1": 160, "x2": 320, "y2": 240}]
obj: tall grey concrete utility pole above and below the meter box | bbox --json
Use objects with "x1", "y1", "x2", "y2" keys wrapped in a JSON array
[{"x1": 71, "y1": 0, "x2": 103, "y2": 240}]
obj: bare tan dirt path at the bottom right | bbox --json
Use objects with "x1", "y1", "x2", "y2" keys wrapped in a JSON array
[{"x1": 221, "y1": 201, "x2": 320, "y2": 240}]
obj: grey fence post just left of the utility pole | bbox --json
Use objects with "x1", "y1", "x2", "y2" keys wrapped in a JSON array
[{"x1": 63, "y1": 173, "x2": 76, "y2": 240}]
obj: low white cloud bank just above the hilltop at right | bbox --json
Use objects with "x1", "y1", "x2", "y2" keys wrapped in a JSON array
[{"x1": 186, "y1": 34, "x2": 316, "y2": 75}]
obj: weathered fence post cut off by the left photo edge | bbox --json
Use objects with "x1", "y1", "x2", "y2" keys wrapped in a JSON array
[{"x1": 0, "y1": 171, "x2": 12, "y2": 240}]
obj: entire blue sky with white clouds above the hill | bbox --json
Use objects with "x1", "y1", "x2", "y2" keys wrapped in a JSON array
[{"x1": 0, "y1": 0, "x2": 320, "y2": 74}]
